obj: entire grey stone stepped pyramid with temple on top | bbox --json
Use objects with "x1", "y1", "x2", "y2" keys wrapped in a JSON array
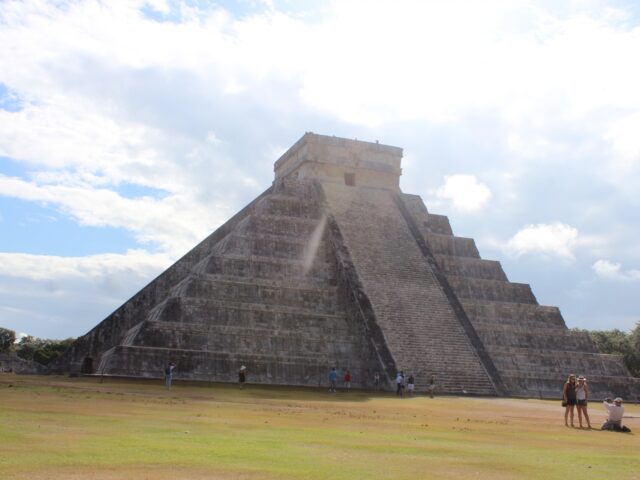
[{"x1": 54, "y1": 133, "x2": 639, "y2": 398}]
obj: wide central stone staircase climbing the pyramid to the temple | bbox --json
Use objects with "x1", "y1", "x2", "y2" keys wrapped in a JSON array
[{"x1": 322, "y1": 183, "x2": 496, "y2": 395}]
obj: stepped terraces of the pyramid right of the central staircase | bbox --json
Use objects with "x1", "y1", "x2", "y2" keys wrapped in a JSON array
[{"x1": 402, "y1": 195, "x2": 637, "y2": 398}]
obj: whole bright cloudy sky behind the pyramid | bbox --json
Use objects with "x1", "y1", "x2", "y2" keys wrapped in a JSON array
[{"x1": 0, "y1": 0, "x2": 640, "y2": 338}]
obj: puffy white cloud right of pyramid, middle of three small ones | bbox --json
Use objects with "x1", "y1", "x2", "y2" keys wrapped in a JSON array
[{"x1": 506, "y1": 222, "x2": 578, "y2": 260}]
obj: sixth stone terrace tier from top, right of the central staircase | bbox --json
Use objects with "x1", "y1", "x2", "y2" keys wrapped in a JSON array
[{"x1": 460, "y1": 298, "x2": 566, "y2": 328}]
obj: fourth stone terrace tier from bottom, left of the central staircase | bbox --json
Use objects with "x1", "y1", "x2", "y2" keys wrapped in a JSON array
[{"x1": 173, "y1": 275, "x2": 338, "y2": 314}]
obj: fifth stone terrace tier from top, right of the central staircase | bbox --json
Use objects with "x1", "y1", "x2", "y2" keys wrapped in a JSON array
[{"x1": 447, "y1": 275, "x2": 538, "y2": 305}]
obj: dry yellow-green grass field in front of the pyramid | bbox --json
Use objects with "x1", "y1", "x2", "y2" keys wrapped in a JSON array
[{"x1": 0, "y1": 374, "x2": 640, "y2": 480}]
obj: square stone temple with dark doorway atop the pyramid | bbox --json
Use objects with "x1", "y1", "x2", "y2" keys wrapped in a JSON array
[{"x1": 274, "y1": 132, "x2": 402, "y2": 191}]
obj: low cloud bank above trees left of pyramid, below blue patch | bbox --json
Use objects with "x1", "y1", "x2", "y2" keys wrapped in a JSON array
[{"x1": 0, "y1": 250, "x2": 173, "y2": 338}]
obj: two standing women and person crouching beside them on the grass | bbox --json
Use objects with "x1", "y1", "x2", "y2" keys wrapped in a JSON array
[{"x1": 562, "y1": 374, "x2": 630, "y2": 432}]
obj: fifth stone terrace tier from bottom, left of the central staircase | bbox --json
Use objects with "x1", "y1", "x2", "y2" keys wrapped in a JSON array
[{"x1": 203, "y1": 254, "x2": 336, "y2": 285}]
